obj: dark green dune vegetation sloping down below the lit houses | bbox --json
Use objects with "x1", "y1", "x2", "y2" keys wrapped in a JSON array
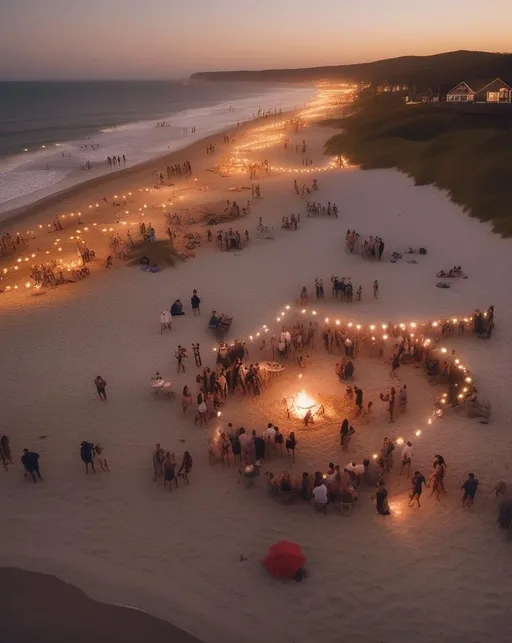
[{"x1": 325, "y1": 92, "x2": 512, "y2": 236}]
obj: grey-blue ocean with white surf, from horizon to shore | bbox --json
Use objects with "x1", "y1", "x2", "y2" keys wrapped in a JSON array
[{"x1": 0, "y1": 81, "x2": 314, "y2": 212}]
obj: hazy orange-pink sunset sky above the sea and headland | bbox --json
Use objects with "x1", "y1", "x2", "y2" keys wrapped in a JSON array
[{"x1": 0, "y1": 0, "x2": 512, "y2": 80}]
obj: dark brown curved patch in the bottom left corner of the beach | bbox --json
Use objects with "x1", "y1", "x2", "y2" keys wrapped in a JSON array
[{"x1": 0, "y1": 567, "x2": 204, "y2": 643}]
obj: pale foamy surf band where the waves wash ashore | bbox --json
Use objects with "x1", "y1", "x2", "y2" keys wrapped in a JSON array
[{"x1": 0, "y1": 87, "x2": 314, "y2": 219}]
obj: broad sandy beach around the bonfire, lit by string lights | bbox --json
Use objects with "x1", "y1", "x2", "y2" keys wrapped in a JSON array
[{"x1": 0, "y1": 89, "x2": 512, "y2": 643}]
